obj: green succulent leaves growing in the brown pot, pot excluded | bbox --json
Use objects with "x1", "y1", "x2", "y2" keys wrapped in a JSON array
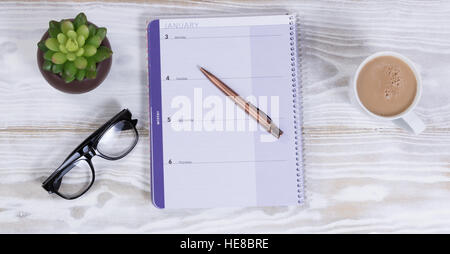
[{"x1": 38, "y1": 13, "x2": 112, "y2": 83}]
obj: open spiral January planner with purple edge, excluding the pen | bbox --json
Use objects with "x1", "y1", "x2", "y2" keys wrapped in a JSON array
[{"x1": 147, "y1": 15, "x2": 304, "y2": 208}]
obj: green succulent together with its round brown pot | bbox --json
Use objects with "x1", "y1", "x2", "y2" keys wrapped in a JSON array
[{"x1": 38, "y1": 13, "x2": 112, "y2": 93}]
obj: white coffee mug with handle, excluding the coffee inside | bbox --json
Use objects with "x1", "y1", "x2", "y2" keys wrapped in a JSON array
[{"x1": 349, "y1": 51, "x2": 425, "y2": 134}]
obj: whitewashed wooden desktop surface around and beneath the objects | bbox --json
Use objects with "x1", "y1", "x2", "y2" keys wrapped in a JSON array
[{"x1": 0, "y1": 1, "x2": 450, "y2": 233}]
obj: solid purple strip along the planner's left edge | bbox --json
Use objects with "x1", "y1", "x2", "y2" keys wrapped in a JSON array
[{"x1": 147, "y1": 20, "x2": 165, "y2": 208}]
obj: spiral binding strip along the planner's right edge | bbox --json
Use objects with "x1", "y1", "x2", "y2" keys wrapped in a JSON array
[{"x1": 289, "y1": 15, "x2": 305, "y2": 204}]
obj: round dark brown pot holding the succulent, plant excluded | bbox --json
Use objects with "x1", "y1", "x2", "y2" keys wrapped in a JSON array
[{"x1": 37, "y1": 23, "x2": 112, "y2": 94}]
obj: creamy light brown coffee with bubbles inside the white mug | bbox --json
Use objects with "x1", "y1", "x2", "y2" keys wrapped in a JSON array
[{"x1": 356, "y1": 56, "x2": 417, "y2": 116}]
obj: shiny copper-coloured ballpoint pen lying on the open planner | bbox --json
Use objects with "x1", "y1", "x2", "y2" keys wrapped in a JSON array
[{"x1": 198, "y1": 66, "x2": 283, "y2": 138}]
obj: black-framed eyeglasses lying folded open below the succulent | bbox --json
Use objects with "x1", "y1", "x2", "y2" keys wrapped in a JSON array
[{"x1": 42, "y1": 109, "x2": 139, "y2": 199}]
